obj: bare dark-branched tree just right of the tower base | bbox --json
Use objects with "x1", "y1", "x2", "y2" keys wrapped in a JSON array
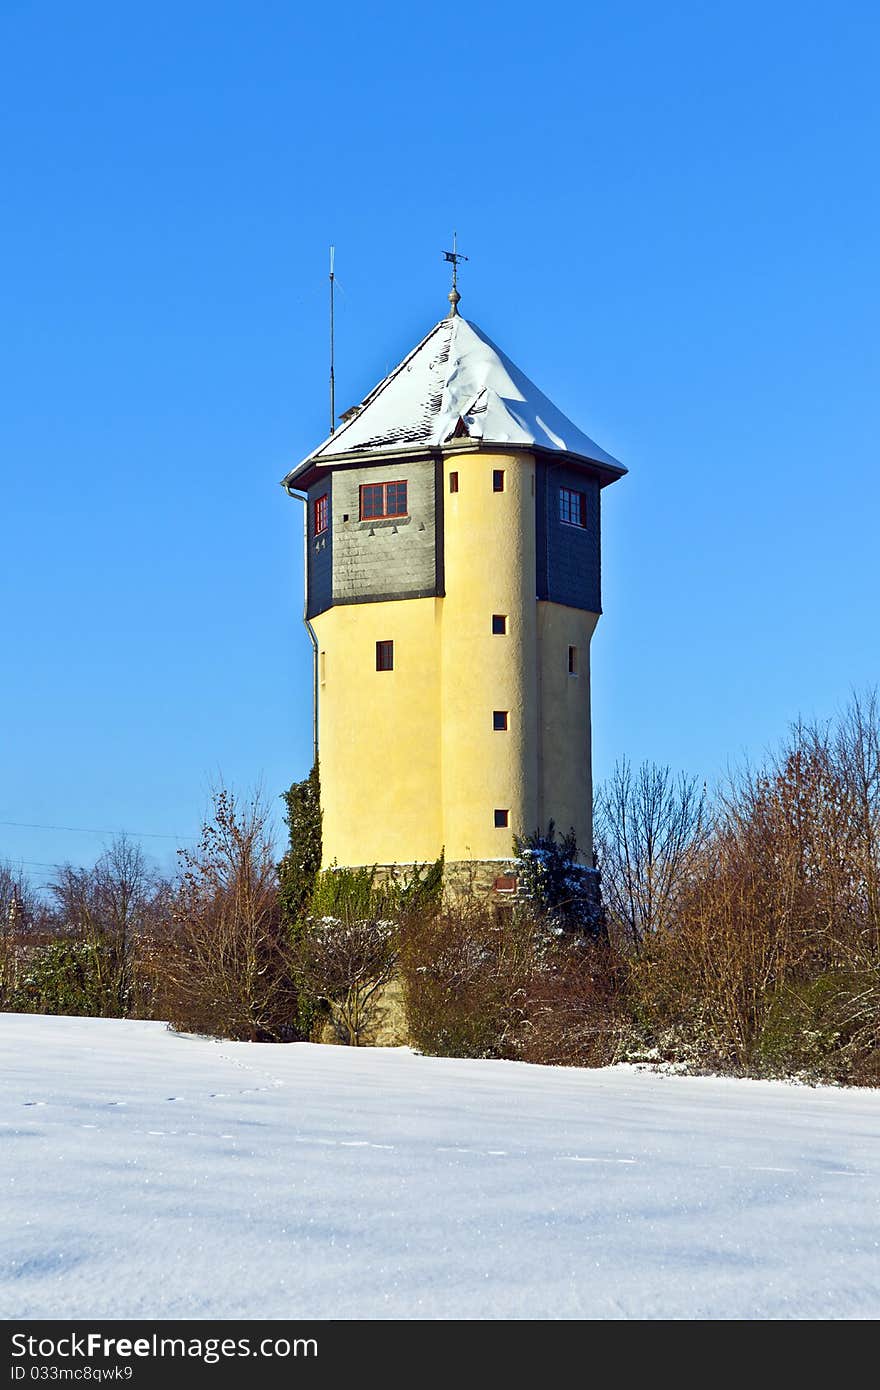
[{"x1": 595, "y1": 759, "x2": 709, "y2": 949}]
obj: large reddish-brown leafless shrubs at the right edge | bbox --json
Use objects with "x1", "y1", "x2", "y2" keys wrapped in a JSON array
[{"x1": 630, "y1": 696, "x2": 880, "y2": 1077}]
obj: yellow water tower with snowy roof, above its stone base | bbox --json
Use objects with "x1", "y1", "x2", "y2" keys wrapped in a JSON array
[{"x1": 284, "y1": 312, "x2": 626, "y2": 891}]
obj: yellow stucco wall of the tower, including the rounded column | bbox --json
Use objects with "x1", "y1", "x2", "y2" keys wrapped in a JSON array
[{"x1": 313, "y1": 449, "x2": 598, "y2": 866}]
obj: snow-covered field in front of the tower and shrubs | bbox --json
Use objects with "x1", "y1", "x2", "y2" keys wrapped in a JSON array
[{"x1": 0, "y1": 1015, "x2": 880, "y2": 1319}]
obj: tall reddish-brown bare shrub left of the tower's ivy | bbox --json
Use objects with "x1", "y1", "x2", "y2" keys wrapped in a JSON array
[{"x1": 164, "y1": 787, "x2": 296, "y2": 1041}]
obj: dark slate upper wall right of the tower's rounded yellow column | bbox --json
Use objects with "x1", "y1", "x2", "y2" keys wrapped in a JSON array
[{"x1": 535, "y1": 459, "x2": 602, "y2": 613}]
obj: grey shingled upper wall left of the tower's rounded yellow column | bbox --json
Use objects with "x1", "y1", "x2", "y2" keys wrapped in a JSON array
[{"x1": 307, "y1": 459, "x2": 442, "y2": 617}]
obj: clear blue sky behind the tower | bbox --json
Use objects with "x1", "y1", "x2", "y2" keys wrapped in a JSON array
[{"x1": 0, "y1": 0, "x2": 880, "y2": 883}]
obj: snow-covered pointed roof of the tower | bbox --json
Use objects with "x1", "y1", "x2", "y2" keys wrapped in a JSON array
[{"x1": 284, "y1": 314, "x2": 627, "y2": 485}]
